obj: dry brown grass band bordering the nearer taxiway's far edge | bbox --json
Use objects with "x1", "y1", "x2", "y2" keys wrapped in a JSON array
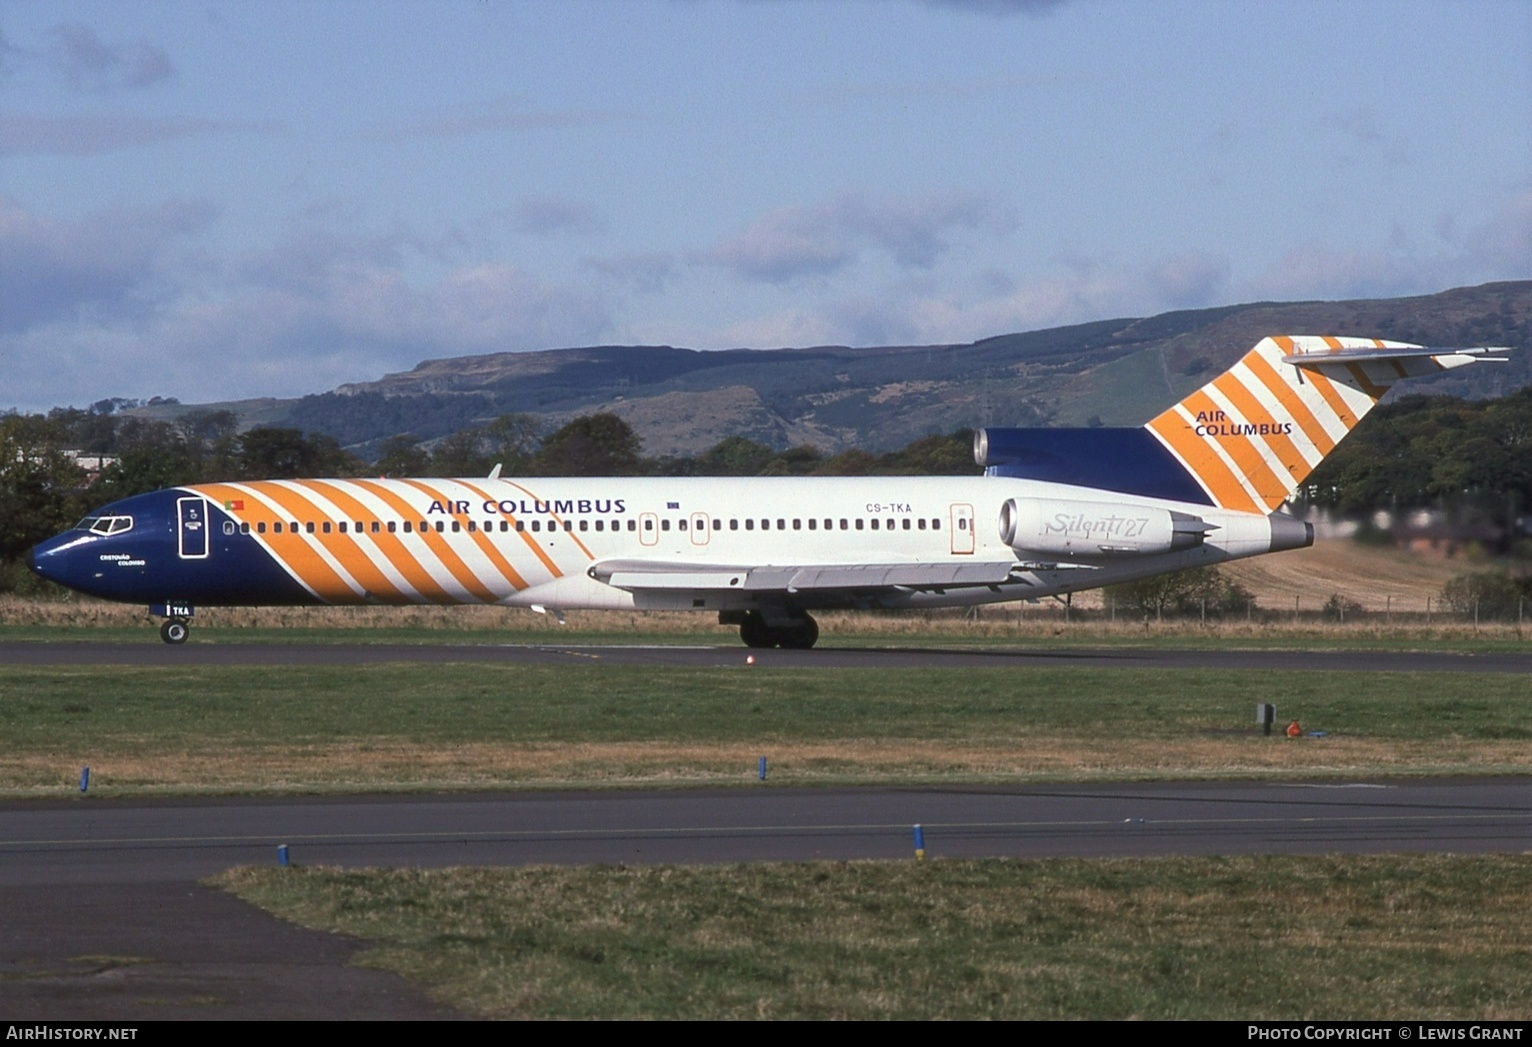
[{"x1": 11, "y1": 736, "x2": 1532, "y2": 796}]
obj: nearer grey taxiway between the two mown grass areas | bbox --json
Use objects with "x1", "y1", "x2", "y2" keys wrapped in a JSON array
[{"x1": 0, "y1": 779, "x2": 1532, "y2": 886}]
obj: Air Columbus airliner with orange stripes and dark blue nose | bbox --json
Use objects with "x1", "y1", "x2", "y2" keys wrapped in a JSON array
[{"x1": 31, "y1": 336, "x2": 1507, "y2": 647}]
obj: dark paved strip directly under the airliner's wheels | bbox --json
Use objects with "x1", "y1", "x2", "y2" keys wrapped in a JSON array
[{"x1": 0, "y1": 638, "x2": 1532, "y2": 673}]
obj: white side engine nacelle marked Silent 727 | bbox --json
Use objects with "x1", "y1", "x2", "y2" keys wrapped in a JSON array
[{"x1": 1000, "y1": 498, "x2": 1216, "y2": 558}]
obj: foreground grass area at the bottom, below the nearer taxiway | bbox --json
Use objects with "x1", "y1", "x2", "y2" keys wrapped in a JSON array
[{"x1": 216, "y1": 855, "x2": 1532, "y2": 1019}]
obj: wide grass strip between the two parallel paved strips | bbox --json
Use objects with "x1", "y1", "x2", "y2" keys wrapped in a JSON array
[{"x1": 9, "y1": 656, "x2": 1532, "y2": 794}]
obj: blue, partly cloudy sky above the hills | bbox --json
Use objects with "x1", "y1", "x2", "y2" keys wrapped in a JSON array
[{"x1": 0, "y1": 0, "x2": 1532, "y2": 411}]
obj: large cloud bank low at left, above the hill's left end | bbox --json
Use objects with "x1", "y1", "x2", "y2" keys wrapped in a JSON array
[{"x1": 0, "y1": 204, "x2": 613, "y2": 409}]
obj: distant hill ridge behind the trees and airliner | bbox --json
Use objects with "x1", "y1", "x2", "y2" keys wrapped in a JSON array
[{"x1": 135, "y1": 281, "x2": 1532, "y2": 455}]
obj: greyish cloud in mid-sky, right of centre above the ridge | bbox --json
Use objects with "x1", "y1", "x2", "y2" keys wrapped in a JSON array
[{"x1": 702, "y1": 193, "x2": 1011, "y2": 284}]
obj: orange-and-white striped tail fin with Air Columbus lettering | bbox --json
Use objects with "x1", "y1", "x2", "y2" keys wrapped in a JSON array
[{"x1": 1144, "y1": 334, "x2": 1507, "y2": 512}]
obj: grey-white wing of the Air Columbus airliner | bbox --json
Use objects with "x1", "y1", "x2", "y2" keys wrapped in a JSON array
[{"x1": 588, "y1": 560, "x2": 1017, "y2": 593}]
